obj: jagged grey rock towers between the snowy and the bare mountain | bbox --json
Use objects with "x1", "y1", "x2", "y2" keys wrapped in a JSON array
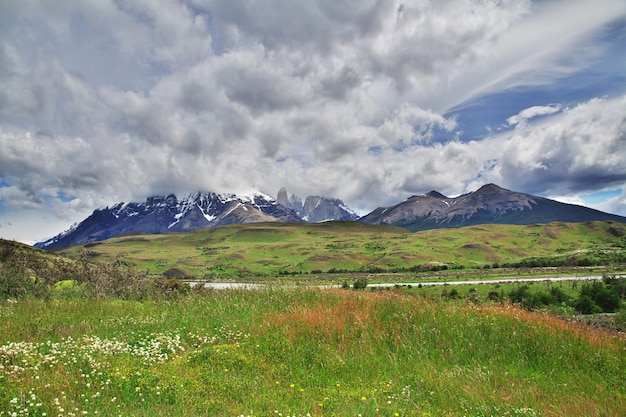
[{"x1": 276, "y1": 187, "x2": 359, "y2": 223}]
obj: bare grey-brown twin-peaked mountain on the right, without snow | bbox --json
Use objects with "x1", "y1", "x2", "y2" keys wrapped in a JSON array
[{"x1": 359, "y1": 184, "x2": 626, "y2": 231}]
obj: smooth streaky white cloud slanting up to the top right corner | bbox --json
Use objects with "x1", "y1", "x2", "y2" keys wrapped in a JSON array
[{"x1": 439, "y1": 0, "x2": 626, "y2": 109}]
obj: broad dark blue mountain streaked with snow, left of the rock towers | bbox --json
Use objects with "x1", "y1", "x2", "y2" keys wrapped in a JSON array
[{"x1": 35, "y1": 192, "x2": 302, "y2": 249}]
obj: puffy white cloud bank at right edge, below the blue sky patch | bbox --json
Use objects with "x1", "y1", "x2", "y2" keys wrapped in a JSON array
[{"x1": 468, "y1": 96, "x2": 626, "y2": 195}]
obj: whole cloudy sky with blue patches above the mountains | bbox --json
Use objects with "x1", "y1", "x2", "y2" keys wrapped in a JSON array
[{"x1": 0, "y1": 0, "x2": 626, "y2": 243}]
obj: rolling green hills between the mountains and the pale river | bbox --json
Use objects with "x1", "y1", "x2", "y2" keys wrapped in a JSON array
[{"x1": 56, "y1": 221, "x2": 626, "y2": 279}]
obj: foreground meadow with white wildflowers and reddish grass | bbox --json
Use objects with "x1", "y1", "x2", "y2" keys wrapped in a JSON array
[{"x1": 0, "y1": 287, "x2": 626, "y2": 416}]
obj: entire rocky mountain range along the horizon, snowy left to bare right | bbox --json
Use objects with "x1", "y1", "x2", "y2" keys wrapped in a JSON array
[{"x1": 35, "y1": 184, "x2": 626, "y2": 249}]
